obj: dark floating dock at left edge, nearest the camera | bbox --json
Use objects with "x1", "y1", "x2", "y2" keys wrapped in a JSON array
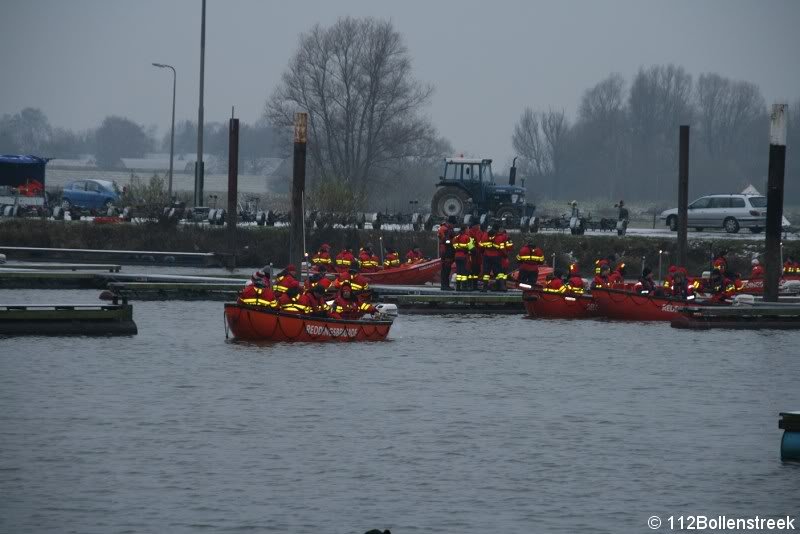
[{"x1": 0, "y1": 303, "x2": 138, "y2": 336}]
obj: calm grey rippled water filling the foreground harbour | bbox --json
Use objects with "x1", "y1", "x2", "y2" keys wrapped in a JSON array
[{"x1": 0, "y1": 290, "x2": 800, "y2": 534}]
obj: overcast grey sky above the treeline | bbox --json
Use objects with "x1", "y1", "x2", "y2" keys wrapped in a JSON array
[{"x1": 0, "y1": 0, "x2": 800, "y2": 162}]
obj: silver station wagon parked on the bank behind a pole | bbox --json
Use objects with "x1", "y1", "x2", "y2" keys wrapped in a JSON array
[{"x1": 661, "y1": 195, "x2": 767, "y2": 234}]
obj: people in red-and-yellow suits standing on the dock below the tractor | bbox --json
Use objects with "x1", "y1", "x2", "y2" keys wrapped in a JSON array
[{"x1": 438, "y1": 217, "x2": 544, "y2": 291}]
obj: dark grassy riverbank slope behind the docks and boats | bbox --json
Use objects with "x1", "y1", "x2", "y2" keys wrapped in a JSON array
[{"x1": 0, "y1": 219, "x2": 800, "y2": 276}]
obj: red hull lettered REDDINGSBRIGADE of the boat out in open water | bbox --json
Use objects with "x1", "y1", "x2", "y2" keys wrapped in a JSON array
[{"x1": 225, "y1": 303, "x2": 392, "y2": 341}]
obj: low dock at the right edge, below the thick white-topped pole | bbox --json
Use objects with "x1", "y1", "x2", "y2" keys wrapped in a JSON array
[{"x1": 671, "y1": 302, "x2": 800, "y2": 330}]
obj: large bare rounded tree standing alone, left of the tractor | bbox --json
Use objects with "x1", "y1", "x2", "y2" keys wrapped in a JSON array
[{"x1": 266, "y1": 17, "x2": 435, "y2": 191}]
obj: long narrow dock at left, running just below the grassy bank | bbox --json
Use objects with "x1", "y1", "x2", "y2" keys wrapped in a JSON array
[{"x1": 0, "y1": 246, "x2": 227, "y2": 267}]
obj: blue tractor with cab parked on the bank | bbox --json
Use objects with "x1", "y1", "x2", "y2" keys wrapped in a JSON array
[{"x1": 431, "y1": 158, "x2": 536, "y2": 225}]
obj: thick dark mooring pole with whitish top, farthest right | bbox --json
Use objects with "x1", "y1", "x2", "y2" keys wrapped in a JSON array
[{"x1": 764, "y1": 104, "x2": 787, "y2": 302}]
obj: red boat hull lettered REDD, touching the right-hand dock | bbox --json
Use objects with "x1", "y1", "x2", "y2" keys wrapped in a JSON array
[{"x1": 592, "y1": 287, "x2": 709, "y2": 321}]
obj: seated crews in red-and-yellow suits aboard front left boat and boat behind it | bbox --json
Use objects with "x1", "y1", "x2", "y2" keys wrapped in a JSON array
[{"x1": 234, "y1": 244, "x2": 425, "y2": 320}]
